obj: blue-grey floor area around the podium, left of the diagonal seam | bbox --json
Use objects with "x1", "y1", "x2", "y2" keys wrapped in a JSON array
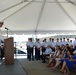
[{"x1": 0, "y1": 59, "x2": 27, "y2": 75}]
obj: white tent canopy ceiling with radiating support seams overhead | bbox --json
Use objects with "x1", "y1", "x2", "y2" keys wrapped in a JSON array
[{"x1": 0, "y1": 0, "x2": 76, "y2": 34}]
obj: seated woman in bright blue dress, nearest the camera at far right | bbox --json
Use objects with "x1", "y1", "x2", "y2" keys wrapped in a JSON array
[{"x1": 60, "y1": 51, "x2": 76, "y2": 75}]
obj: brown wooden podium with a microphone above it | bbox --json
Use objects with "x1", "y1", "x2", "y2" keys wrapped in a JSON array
[{"x1": 4, "y1": 37, "x2": 14, "y2": 65}]
